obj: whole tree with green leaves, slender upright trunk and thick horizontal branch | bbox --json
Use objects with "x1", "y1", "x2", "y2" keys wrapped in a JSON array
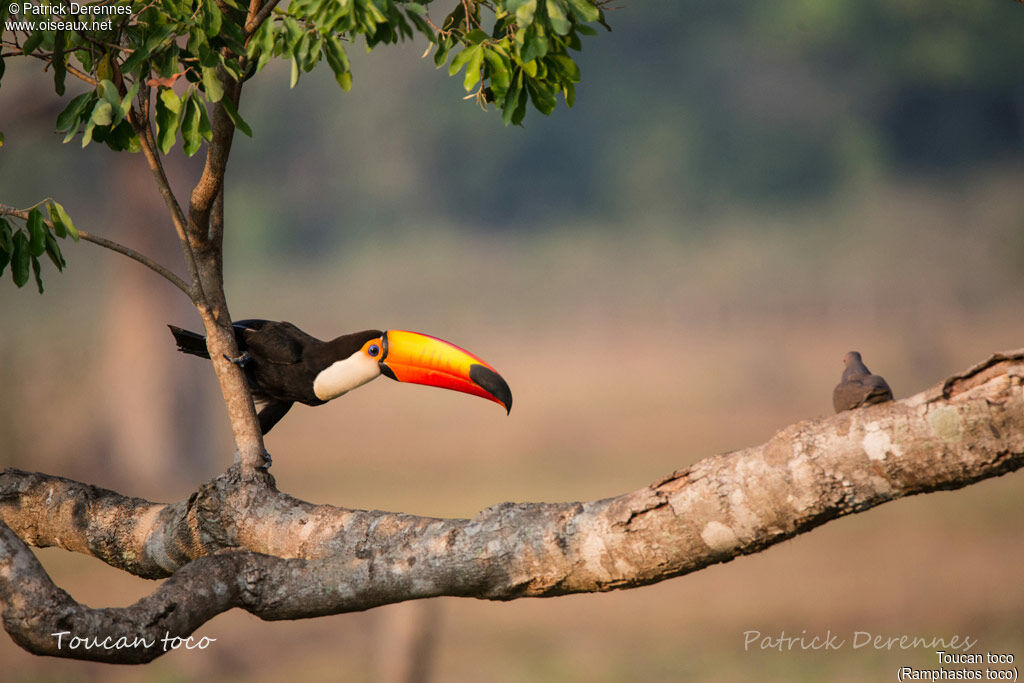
[{"x1": 0, "y1": 0, "x2": 1024, "y2": 663}]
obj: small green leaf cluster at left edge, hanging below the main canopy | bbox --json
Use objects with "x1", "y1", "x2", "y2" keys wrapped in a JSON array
[{"x1": 0, "y1": 200, "x2": 78, "y2": 294}]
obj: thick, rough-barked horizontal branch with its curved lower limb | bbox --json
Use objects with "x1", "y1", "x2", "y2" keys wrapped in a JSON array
[{"x1": 0, "y1": 349, "x2": 1024, "y2": 663}]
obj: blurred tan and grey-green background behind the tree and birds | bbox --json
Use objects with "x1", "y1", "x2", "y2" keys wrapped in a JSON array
[{"x1": 0, "y1": 0, "x2": 1024, "y2": 682}]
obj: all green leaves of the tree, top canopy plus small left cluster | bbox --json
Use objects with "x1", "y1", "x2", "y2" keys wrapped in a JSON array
[{"x1": 0, "y1": 0, "x2": 603, "y2": 292}]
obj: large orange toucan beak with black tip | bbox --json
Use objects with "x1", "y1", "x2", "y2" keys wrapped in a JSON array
[{"x1": 378, "y1": 330, "x2": 512, "y2": 413}]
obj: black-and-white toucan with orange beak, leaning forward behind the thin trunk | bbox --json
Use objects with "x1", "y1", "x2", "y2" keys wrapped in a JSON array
[{"x1": 167, "y1": 319, "x2": 512, "y2": 434}]
